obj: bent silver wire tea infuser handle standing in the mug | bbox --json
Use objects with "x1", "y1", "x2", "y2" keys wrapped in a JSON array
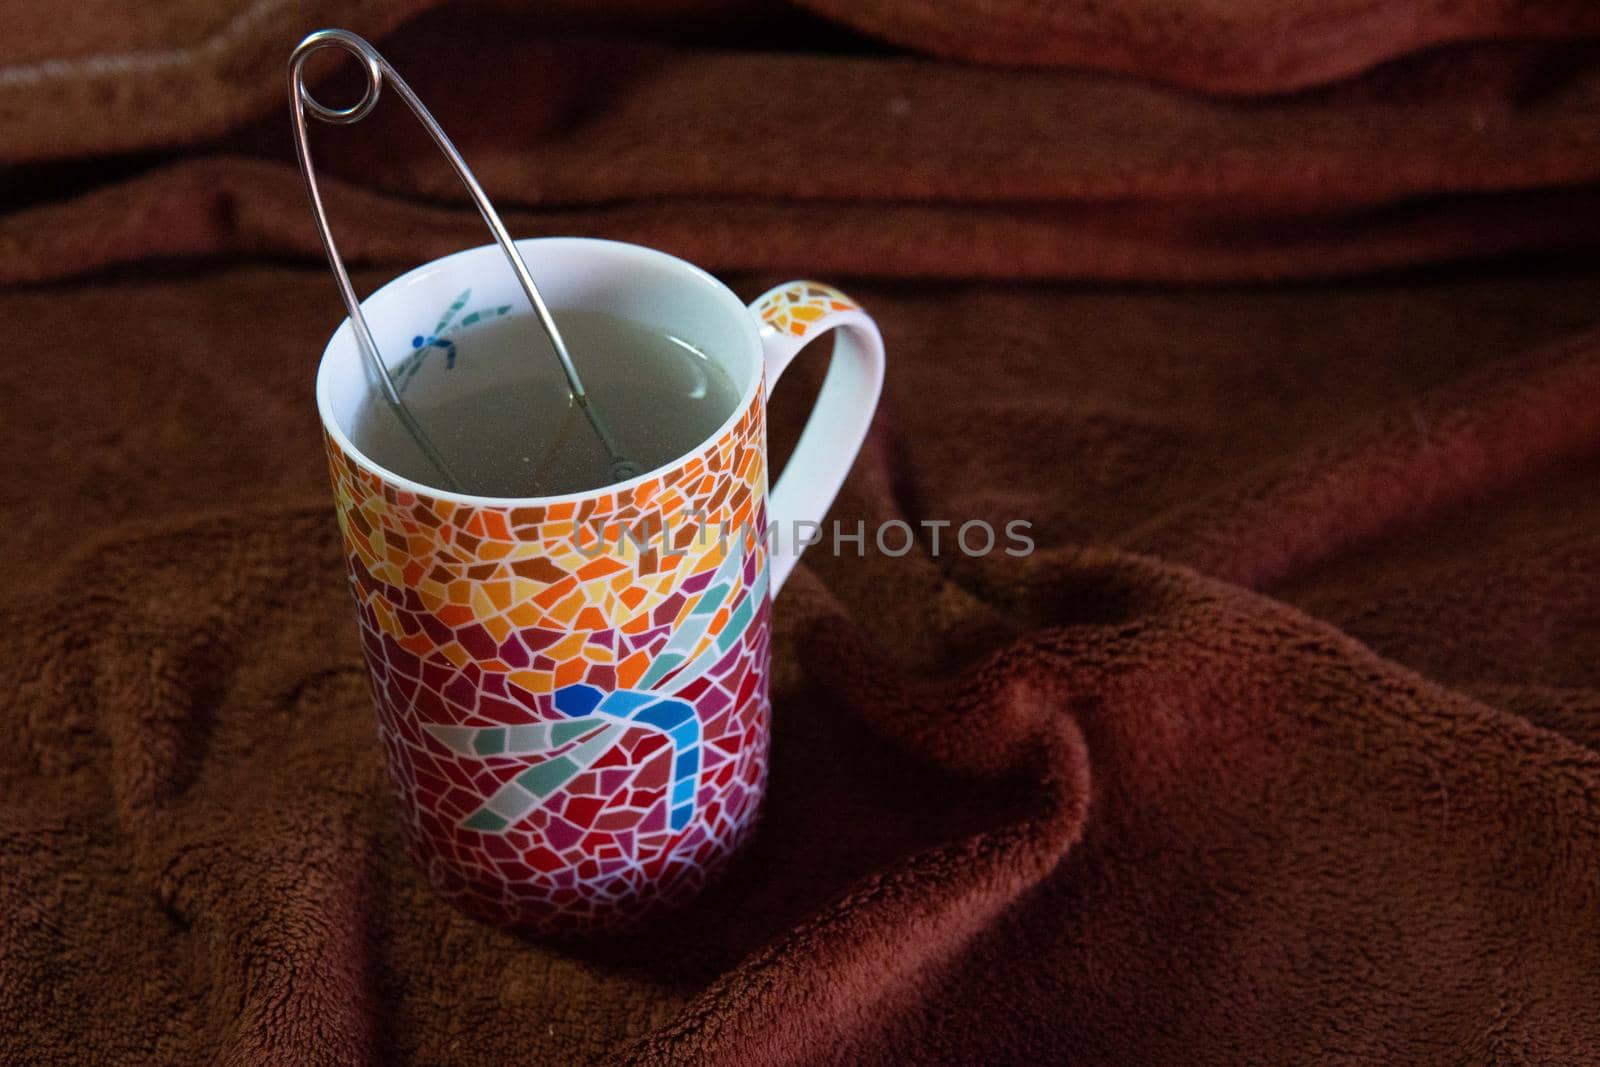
[{"x1": 290, "y1": 29, "x2": 640, "y2": 491}]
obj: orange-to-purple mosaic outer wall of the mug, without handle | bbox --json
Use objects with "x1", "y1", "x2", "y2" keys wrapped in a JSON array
[{"x1": 328, "y1": 388, "x2": 770, "y2": 929}]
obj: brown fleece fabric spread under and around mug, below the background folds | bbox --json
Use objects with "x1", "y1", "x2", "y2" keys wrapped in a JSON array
[{"x1": 0, "y1": 255, "x2": 1600, "y2": 1064}]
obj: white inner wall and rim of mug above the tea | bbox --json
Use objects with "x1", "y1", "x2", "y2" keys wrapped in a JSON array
[{"x1": 317, "y1": 237, "x2": 762, "y2": 504}]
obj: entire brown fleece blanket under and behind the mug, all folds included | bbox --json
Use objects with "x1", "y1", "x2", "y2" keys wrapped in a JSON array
[{"x1": 0, "y1": 3, "x2": 1600, "y2": 1064}]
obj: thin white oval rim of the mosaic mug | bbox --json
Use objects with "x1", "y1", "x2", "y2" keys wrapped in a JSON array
[{"x1": 315, "y1": 237, "x2": 765, "y2": 507}]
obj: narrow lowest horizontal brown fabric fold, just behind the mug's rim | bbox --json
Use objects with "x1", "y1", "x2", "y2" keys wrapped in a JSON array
[{"x1": 15, "y1": 158, "x2": 1600, "y2": 283}]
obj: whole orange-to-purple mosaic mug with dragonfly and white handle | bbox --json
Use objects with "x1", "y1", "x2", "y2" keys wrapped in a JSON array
[{"x1": 317, "y1": 238, "x2": 883, "y2": 931}]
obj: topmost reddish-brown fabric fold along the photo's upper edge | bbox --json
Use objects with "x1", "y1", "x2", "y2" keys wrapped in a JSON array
[{"x1": 9, "y1": 0, "x2": 1600, "y2": 158}]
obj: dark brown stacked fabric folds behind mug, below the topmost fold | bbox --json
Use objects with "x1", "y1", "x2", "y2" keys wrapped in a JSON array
[{"x1": 12, "y1": 30, "x2": 1600, "y2": 282}]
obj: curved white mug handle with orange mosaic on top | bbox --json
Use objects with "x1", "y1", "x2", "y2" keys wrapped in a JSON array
[{"x1": 750, "y1": 282, "x2": 883, "y2": 597}]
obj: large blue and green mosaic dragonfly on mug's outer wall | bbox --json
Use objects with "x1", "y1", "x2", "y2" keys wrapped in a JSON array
[{"x1": 424, "y1": 537, "x2": 766, "y2": 833}]
